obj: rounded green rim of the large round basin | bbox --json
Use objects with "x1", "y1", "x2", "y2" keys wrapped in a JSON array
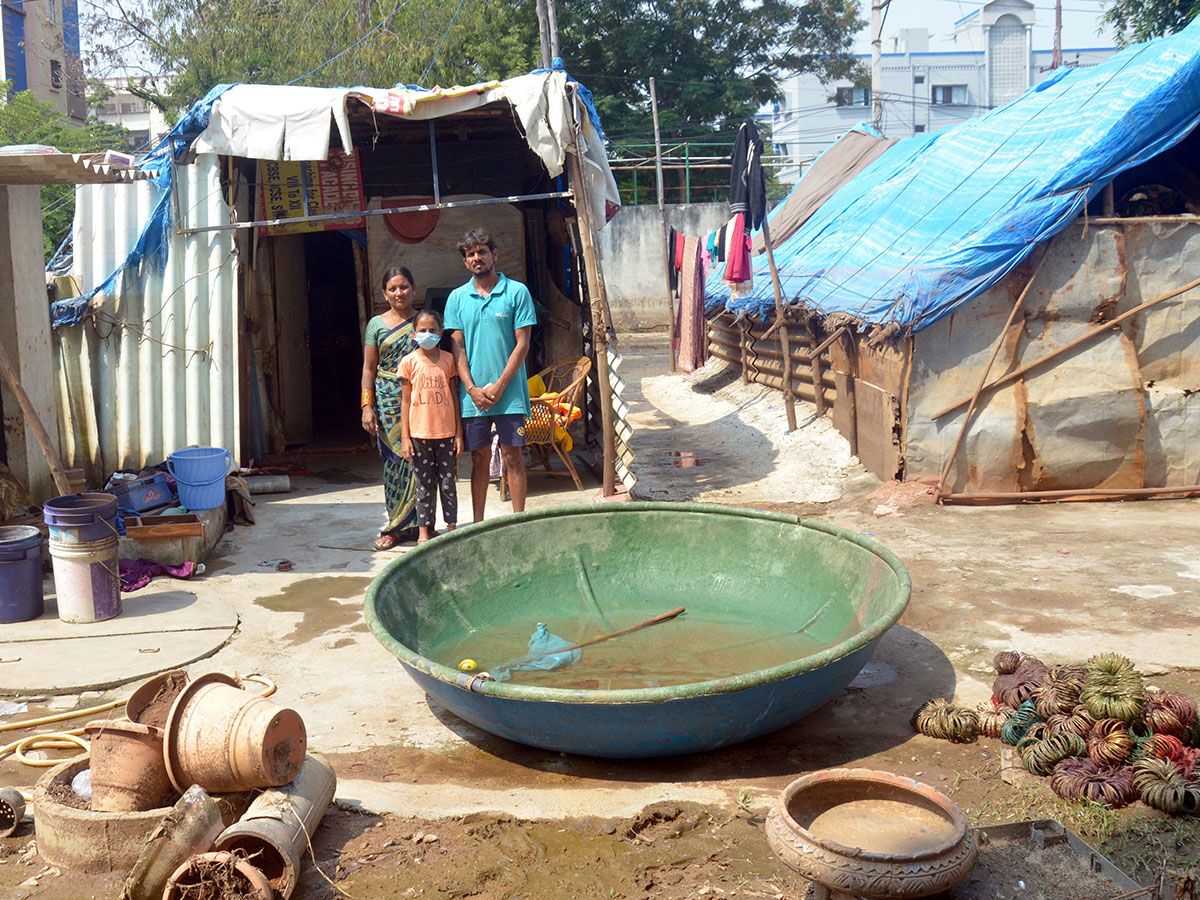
[{"x1": 364, "y1": 500, "x2": 912, "y2": 703}]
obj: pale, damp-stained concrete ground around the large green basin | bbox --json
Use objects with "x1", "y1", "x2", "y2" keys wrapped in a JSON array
[{"x1": 0, "y1": 344, "x2": 1200, "y2": 818}]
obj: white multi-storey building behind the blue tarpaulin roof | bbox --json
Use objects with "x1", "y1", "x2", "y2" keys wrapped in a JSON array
[{"x1": 772, "y1": 0, "x2": 1116, "y2": 181}]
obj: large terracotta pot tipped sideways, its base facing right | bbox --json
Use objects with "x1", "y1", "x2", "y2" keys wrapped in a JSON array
[{"x1": 166, "y1": 672, "x2": 308, "y2": 793}]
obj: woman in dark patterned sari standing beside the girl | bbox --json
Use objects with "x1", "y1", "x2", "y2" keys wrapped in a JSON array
[{"x1": 362, "y1": 266, "x2": 416, "y2": 550}]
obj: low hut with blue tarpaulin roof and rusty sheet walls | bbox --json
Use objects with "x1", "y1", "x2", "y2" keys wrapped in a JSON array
[{"x1": 706, "y1": 23, "x2": 1200, "y2": 499}]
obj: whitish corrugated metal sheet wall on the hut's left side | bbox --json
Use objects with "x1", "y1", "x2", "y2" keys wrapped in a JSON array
[{"x1": 54, "y1": 156, "x2": 240, "y2": 480}]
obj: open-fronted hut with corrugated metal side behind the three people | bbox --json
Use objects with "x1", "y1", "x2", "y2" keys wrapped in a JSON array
[{"x1": 52, "y1": 68, "x2": 628, "y2": 494}]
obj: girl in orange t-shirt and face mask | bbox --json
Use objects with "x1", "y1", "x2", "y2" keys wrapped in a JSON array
[{"x1": 400, "y1": 310, "x2": 462, "y2": 544}]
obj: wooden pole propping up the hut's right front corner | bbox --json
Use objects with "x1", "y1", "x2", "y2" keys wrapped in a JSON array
[{"x1": 566, "y1": 94, "x2": 617, "y2": 497}]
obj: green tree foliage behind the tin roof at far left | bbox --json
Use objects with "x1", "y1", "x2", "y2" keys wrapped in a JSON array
[{"x1": 0, "y1": 82, "x2": 128, "y2": 258}]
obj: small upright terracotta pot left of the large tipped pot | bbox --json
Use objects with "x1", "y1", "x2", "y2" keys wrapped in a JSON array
[{"x1": 84, "y1": 721, "x2": 170, "y2": 812}]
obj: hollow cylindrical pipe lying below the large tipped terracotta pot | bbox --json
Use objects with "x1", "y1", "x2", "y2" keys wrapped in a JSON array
[{"x1": 215, "y1": 755, "x2": 337, "y2": 900}]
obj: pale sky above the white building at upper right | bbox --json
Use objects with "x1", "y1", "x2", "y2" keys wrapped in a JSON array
[{"x1": 854, "y1": 0, "x2": 1112, "y2": 53}]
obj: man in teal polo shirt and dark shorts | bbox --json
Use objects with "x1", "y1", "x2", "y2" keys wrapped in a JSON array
[{"x1": 445, "y1": 229, "x2": 538, "y2": 522}]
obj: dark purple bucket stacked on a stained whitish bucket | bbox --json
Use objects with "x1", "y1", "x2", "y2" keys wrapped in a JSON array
[{"x1": 42, "y1": 493, "x2": 121, "y2": 623}]
